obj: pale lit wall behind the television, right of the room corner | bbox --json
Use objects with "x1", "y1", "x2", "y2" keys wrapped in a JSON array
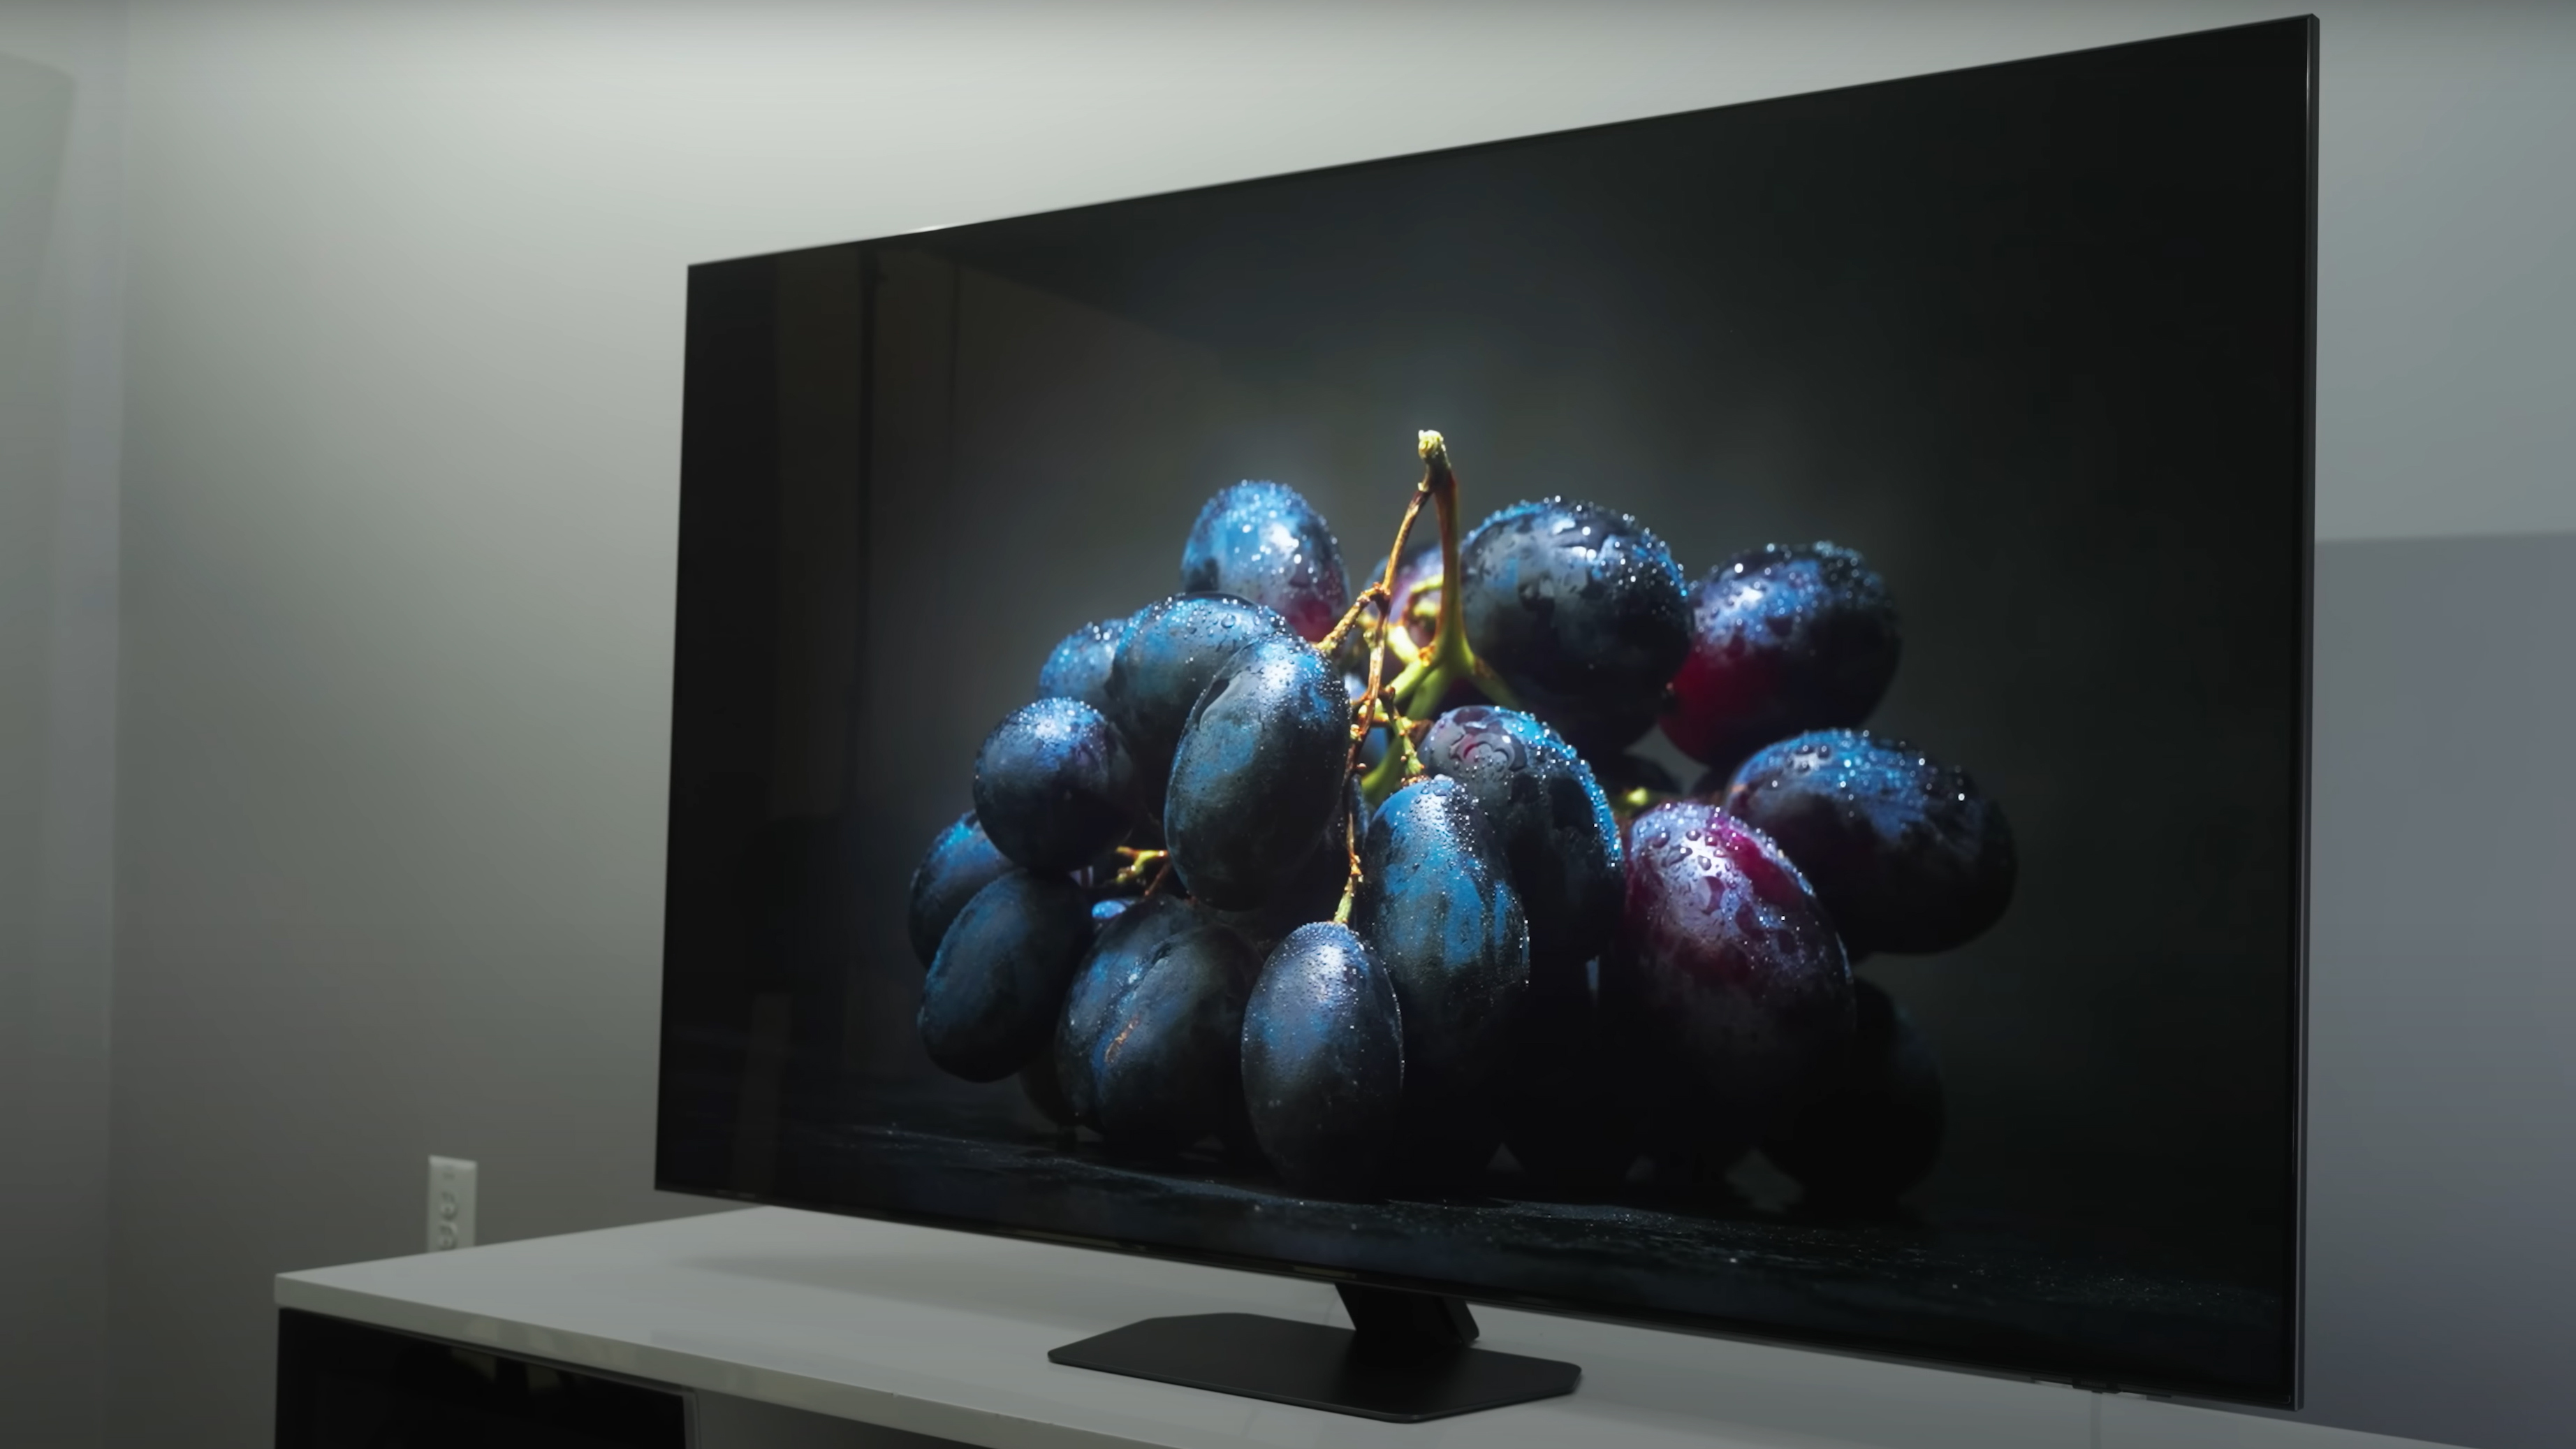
[{"x1": 100, "y1": 0, "x2": 2576, "y2": 1449}]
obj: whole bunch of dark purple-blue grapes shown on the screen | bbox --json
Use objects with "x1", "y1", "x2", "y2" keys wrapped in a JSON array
[{"x1": 909, "y1": 433, "x2": 2014, "y2": 1202}]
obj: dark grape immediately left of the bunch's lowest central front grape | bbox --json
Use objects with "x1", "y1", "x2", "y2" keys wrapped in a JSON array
[{"x1": 1087, "y1": 926, "x2": 1262, "y2": 1153}]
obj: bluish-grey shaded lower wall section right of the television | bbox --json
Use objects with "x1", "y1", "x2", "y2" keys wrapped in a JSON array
[{"x1": 2308, "y1": 537, "x2": 2576, "y2": 1449}]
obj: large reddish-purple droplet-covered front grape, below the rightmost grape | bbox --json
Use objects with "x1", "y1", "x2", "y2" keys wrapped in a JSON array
[{"x1": 1602, "y1": 799, "x2": 1852, "y2": 1160}]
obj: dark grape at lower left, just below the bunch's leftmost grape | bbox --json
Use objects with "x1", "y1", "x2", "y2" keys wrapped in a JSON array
[{"x1": 920, "y1": 871, "x2": 1092, "y2": 1083}]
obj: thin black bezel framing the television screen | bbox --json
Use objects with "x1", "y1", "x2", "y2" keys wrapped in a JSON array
[{"x1": 654, "y1": 15, "x2": 2321, "y2": 1411}]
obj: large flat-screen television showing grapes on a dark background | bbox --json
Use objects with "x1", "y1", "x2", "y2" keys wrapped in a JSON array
[{"x1": 657, "y1": 18, "x2": 2316, "y2": 1408}]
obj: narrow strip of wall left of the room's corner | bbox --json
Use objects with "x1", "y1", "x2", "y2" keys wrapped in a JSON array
[{"x1": 0, "y1": 3, "x2": 124, "y2": 1444}]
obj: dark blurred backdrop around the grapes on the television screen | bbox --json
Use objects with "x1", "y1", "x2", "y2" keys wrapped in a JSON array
[{"x1": 662, "y1": 23, "x2": 2308, "y2": 1387}]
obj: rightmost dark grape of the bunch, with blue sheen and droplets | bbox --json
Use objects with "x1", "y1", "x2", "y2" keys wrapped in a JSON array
[{"x1": 1726, "y1": 729, "x2": 2014, "y2": 954}]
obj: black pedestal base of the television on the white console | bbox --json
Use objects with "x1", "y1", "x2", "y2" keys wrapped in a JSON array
[{"x1": 1046, "y1": 1284, "x2": 1584, "y2": 1423}]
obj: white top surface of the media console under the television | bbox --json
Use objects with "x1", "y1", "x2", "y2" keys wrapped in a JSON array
[{"x1": 276, "y1": 1209, "x2": 2411, "y2": 1449}]
